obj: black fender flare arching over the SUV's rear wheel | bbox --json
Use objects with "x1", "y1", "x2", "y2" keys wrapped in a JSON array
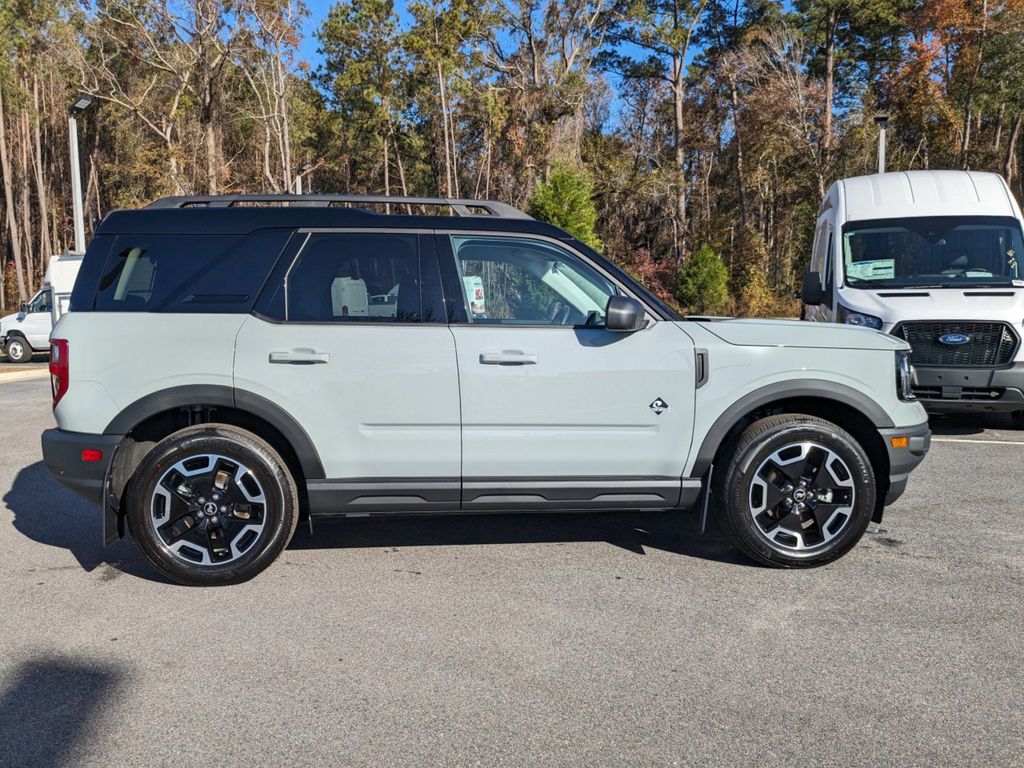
[{"x1": 103, "y1": 384, "x2": 325, "y2": 480}]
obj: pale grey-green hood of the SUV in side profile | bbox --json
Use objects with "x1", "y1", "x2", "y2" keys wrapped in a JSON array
[{"x1": 692, "y1": 318, "x2": 910, "y2": 351}]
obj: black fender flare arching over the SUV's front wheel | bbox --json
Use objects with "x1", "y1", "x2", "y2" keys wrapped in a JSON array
[{"x1": 689, "y1": 379, "x2": 894, "y2": 477}]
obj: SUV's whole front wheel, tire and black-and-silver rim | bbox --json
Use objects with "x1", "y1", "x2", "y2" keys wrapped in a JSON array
[{"x1": 712, "y1": 414, "x2": 878, "y2": 567}]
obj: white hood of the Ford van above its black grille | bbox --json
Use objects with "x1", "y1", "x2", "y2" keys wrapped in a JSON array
[{"x1": 839, "y1": 288, "x2": 1024, "y2": 328}]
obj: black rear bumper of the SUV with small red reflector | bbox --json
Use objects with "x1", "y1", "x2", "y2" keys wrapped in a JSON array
[{"x1": 42, "y1": 429, "x2": 122, "y2": 539}]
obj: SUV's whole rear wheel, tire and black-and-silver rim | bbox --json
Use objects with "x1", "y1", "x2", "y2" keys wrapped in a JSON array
[{"x1": 127, "y1": 424, "x2": 299, "y2": 587}]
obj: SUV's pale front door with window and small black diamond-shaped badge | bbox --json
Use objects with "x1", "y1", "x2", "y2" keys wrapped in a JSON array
[{"x1": 438, "y1": 233, "x2": 695, "y2": 510}]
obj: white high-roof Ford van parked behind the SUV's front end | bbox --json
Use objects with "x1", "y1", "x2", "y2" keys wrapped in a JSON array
[{"x1": 802, "y1": 171, "x2": 1024, "y2": 427}]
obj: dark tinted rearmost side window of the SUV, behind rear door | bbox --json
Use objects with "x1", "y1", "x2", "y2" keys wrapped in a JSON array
[{"x1": 94, "y1": 229, "x2": 291, "y2": 313}]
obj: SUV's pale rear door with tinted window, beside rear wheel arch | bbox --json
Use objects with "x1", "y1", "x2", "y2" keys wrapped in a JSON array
[{"x1": 234, "y1": 230, "x2": 460, "y2": 513}]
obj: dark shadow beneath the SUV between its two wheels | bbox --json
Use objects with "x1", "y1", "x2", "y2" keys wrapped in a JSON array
[{"x1": 291, "y1": 511, "x2": 761, "y2": 567}]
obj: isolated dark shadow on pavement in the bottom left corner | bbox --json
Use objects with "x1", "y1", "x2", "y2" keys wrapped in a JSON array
[{"x1": 0, "y1": 656, "x2": 125, "y2": 768}]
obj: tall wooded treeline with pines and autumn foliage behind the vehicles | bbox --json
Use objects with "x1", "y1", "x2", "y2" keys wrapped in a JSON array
[{"x1": 0, "y1": 0, "x2": 1024, "y2": 314}]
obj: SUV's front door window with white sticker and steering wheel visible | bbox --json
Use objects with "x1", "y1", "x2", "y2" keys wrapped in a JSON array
[{"x1": 452, "y1": 236, "x2": 616, "y2": 326}]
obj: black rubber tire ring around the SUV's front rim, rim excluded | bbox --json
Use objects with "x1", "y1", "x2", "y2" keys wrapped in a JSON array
[{"x1": 724, "y1": 422, "x2": 878, "y2": 566}]
